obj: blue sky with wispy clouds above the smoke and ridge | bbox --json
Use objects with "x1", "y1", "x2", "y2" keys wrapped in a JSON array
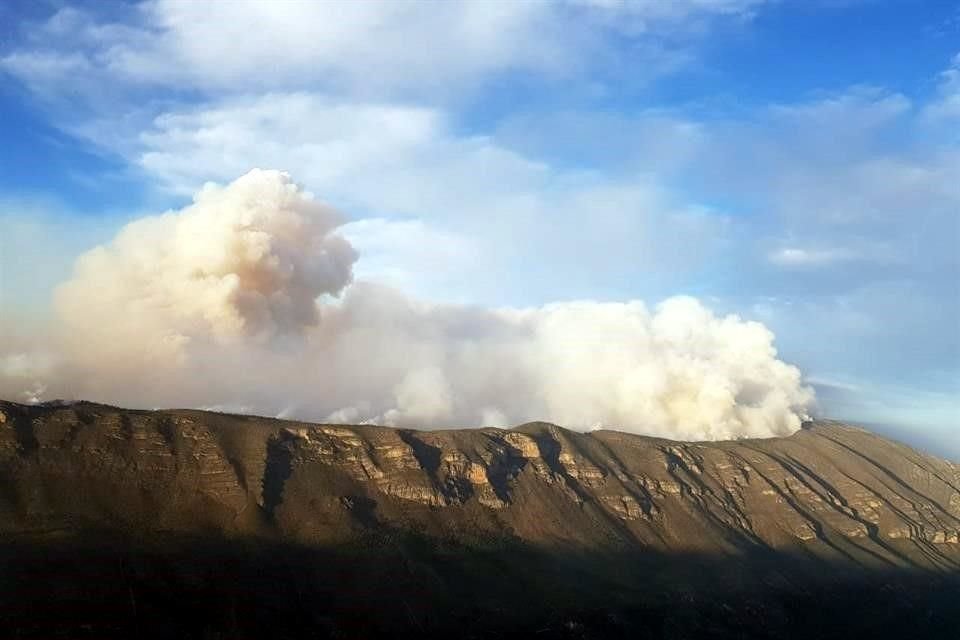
[{"x1": 0, "y1": 0, "x2": 960, "y2": 457}]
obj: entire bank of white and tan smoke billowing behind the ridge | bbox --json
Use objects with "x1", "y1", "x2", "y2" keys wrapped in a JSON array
[{"x1": 0, "y1": 170, "x2": 813, "y2": 439}]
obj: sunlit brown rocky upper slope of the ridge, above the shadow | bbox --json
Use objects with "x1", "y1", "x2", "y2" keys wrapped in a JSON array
[{"x1": 0, "y1": 403, "x2": 960, "y2": 569}]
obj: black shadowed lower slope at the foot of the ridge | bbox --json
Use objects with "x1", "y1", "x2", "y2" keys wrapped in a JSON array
[{"x1": 0, "y1": 532, "x2": 960, "y2": 639}]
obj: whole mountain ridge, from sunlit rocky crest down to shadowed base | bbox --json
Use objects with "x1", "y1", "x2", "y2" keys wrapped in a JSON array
[{"x1": 0, "y1": 402, "x2": 960, "y2": 639}]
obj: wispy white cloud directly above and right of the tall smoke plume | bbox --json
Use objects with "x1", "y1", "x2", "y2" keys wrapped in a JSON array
[{"x1": 75, "y1": 92, "x2": 729, "y2": 302}]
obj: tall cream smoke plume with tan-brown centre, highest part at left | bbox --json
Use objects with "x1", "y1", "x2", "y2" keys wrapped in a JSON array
[{"x1": 56, "y1": 170, "x2": 356, "y2": 367}]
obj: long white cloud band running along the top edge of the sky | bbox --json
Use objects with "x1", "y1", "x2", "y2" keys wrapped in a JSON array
[{"x1": 0, "y1": 0, "x2": 761, "y2": 98}]
